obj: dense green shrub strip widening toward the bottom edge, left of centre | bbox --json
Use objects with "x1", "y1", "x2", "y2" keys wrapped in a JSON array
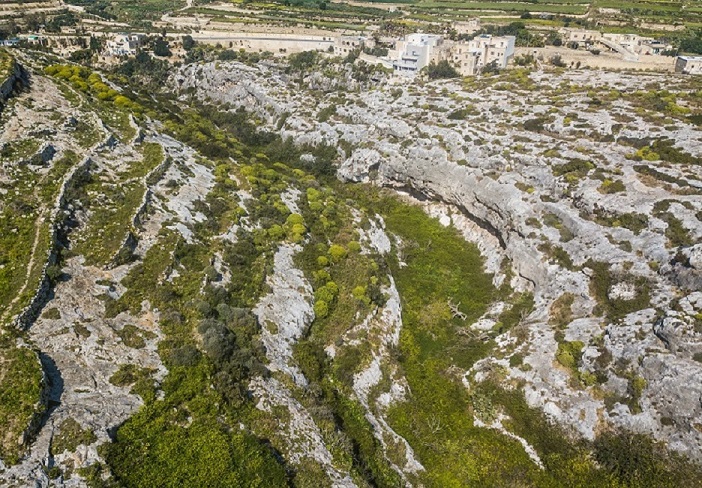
[{"x1": 105, "y1": 221, "x2": 286, "y2": 486}]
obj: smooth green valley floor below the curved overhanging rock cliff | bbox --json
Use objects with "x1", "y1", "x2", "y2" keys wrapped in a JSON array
[{"x1": 372, "y1": 196, "x2": 538, "y2": 486}]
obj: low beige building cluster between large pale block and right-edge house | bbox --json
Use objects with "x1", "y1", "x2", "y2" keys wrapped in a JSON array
[{"x1": 559, "y1": 28, "x2": 672, "y2": 59}]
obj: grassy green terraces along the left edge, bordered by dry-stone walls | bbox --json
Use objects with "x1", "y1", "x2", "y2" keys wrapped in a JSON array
[{"x1": 0, "y1": 63, "x2": 96, "y2": 464}]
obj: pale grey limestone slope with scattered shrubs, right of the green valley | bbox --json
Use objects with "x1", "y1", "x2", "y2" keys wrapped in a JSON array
[{"x1": 174, "y1": 60, "x2": 702, "y2": 457}]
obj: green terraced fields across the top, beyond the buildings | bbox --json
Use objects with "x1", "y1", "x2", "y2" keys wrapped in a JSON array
[{"x1": 160, "y1": 0, "x2": 702, "y2": 37}]
